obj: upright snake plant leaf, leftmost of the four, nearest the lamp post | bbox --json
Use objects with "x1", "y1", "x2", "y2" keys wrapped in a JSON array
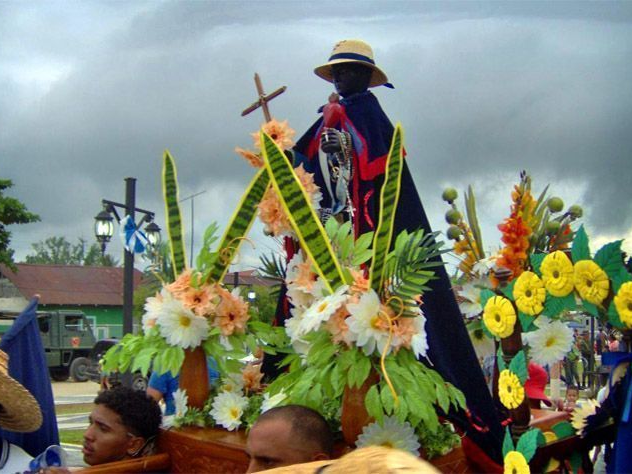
[{"x1": 162, "y1": 150, "x2": 186, "y2": 276}]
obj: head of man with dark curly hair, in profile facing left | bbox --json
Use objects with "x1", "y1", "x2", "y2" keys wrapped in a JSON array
[{"x1": 82, "y1": 387, "x2": 162, "y2": 466}]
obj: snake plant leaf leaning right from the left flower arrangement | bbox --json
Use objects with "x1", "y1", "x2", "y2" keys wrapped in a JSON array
[{"x1": 206, "y1": 168, "x2": 270, "y2": 283}]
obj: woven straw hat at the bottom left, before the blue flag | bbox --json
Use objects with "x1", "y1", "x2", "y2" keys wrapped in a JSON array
[{"x1": 0, "y1": 350, "x2": 42, "y2": 433}]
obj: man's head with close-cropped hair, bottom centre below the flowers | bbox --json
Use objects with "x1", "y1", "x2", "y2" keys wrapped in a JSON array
[{"x1": 246, "y1": 405, "x2": 333, "y2": 473}]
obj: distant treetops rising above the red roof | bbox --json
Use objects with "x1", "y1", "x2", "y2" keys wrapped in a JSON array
[{"x1": 25, "y1": 236, "x2": 118, "y2": 267}]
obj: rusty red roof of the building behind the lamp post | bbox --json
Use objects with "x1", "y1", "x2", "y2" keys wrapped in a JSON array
[{"x1": 0, "y1": 263, "x2": 143, "y2": 306}]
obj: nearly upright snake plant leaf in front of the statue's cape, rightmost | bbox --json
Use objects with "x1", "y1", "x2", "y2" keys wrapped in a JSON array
[{"x1": 369, "y1": 123, "x2": 404, "y2": 293}]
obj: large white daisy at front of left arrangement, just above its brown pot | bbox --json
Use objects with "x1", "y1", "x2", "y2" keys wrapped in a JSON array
[{"x1": 157, "y1": 298, "x2": 208, "y2": 349}]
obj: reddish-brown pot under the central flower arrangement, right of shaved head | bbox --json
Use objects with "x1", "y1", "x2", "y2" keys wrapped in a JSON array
[{"x1": 340, "y1": 370, "x2": 380, "y2": 446}]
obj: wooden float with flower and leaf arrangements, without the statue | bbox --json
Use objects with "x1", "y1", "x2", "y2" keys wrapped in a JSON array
[{"x1": 90, "y1": 78, "x2": 632, "y2": 473}]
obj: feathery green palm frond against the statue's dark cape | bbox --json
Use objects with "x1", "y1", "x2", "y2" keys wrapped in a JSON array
[{"x1": 385, "y1": 229, "x2": 445, "y2": 317}]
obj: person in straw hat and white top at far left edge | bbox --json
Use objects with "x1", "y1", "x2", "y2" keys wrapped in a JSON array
[{"x1": 0, "y1": 350, "x2": 42, "y2": 473}]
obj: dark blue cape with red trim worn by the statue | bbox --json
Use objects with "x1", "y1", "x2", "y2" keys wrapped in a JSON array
[{"x1": 294, "y1": 91, "x2": 503, "y2": 463}]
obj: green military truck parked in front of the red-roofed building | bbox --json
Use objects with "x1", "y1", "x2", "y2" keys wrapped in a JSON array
[{"x1": 0, "y1": 310, "x2": 96, "y2": 382}]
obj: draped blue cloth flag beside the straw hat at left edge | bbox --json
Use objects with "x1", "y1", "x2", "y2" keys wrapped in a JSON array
[{"x1": 0, "y1": 298, "x2": 59, "y2": 457}]
